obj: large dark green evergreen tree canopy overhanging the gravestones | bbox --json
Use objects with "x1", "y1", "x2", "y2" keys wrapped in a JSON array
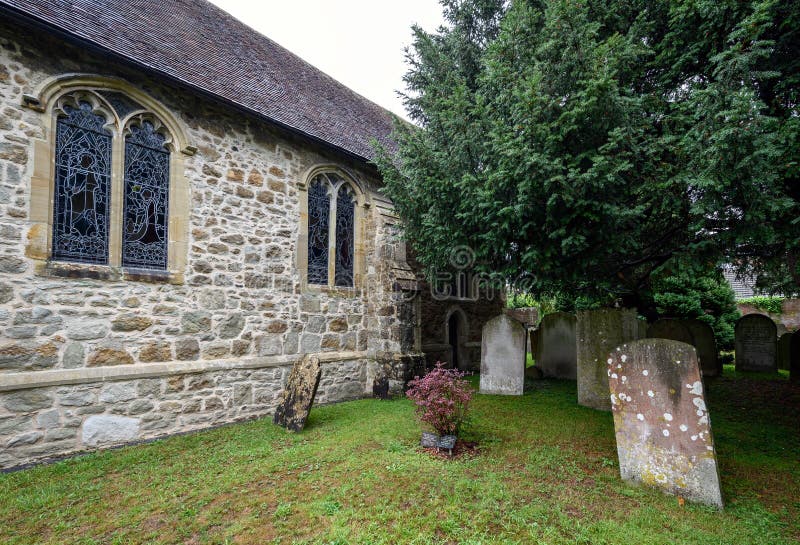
[{"x1": 379, "y1": 0, "x2": 800, "y2": 306}]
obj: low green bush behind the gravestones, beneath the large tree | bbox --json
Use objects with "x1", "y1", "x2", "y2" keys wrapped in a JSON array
[{"x1": 652, "y1": 264, "x2": 741, "y2": 350}]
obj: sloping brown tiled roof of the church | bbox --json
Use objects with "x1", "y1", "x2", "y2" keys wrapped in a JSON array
[{"x1": 0, "y1": 0, "x2": 392, "y2": 159}]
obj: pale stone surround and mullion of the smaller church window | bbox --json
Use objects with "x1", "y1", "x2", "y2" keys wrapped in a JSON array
[{"x1": 296, "y1": 164, "x2": 370, "y2": 296}]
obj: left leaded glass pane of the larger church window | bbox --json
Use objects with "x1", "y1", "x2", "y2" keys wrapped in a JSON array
[{"x1": 53, "y1": 101, "x2": 111, "y2": 263}]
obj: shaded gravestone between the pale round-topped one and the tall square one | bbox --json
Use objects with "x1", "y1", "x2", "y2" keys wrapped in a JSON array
[{"x1": 536, "y1": 312, "x2": 578, "y2": 380}]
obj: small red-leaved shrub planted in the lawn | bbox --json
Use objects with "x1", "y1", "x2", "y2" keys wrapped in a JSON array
[{"x1": 406, "y1": 361, "x2": 472, "y2": 435}]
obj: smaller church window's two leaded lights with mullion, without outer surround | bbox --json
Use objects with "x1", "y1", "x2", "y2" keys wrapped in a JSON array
[{"x1": 306, "y1": 172, "x2": 358, "y2": 288}]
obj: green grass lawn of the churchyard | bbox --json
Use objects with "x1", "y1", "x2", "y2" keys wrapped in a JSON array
[{"x1": 0, "y1": 377, "x2": 800, "y2": 545}]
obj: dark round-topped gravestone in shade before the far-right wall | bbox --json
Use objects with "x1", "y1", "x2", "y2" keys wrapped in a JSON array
[{"x1": 734, "y1": 314, "x2": 778, "y2": 373}]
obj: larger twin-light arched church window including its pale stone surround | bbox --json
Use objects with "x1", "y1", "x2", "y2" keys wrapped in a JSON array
[{"x1": 24, "y1": 75, "x2": 195, "y2": 283}]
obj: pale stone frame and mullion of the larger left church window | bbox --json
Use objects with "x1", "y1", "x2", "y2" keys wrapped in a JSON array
[{"x1": 23, "y1": 74, "x2": 197, "y2": 284}]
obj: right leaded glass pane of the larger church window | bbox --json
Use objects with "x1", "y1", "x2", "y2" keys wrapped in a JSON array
[{"x1": 122, "y1": 121, "x2": 169, "y2": 269}]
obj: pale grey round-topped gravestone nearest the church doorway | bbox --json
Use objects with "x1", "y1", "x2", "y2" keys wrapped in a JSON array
[{"x1": 480, "y1": 314, "x2": 527, "y2": 395}]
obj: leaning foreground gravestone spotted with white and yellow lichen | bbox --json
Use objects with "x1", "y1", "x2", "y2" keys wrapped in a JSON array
[{"x1": 607, "y1": 339, "x2": 722, "y2": 509}]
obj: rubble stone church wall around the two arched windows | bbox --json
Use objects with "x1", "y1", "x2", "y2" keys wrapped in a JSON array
[{"x1": 0, "y1": 22, "x2": 422, "y2": 467}]
